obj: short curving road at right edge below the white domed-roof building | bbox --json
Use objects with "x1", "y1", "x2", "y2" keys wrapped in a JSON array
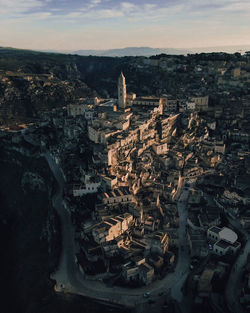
[{"x1": 225, "y1": 217, "x2": 250, "y2": 313}]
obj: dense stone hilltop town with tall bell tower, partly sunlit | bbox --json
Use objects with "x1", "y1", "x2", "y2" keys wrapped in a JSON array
[{"x1": 0, "y1": 51, "x2": 250, "y2": 313}]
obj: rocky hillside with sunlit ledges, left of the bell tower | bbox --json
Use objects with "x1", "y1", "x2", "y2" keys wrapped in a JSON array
[{"x1": 0, "y1": 72, "x2": 95, "y2": 122}]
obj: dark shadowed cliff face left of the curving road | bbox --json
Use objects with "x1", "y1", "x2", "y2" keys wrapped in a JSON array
[{"x1": 0, "y1": 138, "x2": 60, "y2": 312}]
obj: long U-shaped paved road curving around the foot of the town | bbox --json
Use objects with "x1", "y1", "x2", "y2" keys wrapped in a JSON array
[{"x1": 44, "y1": 152, "x2": 189, "y2": 312}]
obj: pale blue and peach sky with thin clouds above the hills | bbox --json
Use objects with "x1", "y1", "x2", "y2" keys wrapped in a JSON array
[{"x1": 0, "y1": 0, "x2": 250, "y2": 50}]
